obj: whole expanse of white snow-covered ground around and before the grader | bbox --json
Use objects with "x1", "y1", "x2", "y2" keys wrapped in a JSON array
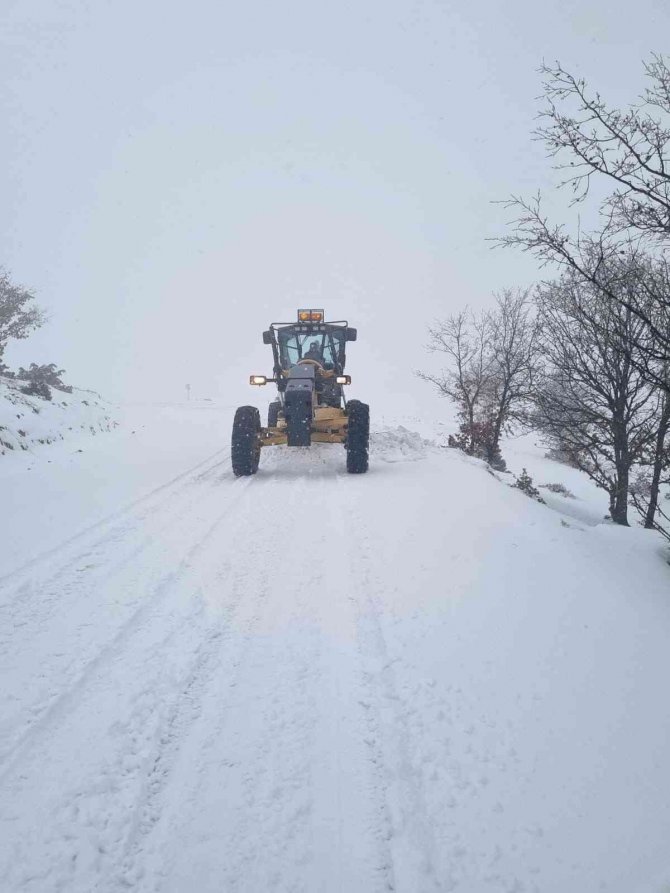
[{"x1": 0, "y1": 404, "x2": 670, "y2": 893}]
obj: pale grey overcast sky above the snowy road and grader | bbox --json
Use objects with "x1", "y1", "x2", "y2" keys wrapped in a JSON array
[{"x1": 0, "y1": 0, "x2": 670, "y2": 410}]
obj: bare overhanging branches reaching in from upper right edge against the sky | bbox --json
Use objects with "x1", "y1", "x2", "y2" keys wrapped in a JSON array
[{"x1": 498, "y1": 55, "x2": 670, "y2": 373}]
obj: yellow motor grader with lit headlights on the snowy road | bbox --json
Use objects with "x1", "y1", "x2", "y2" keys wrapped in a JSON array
[{"x1": 231, "y1": 309, "x2": 370, "y2": 477}]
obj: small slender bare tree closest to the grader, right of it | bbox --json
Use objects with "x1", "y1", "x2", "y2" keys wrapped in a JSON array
[{"x1": 417, "y1": 307, "x2": 491, "y2": 455}]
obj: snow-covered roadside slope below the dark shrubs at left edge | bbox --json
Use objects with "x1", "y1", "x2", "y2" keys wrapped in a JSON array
[{"x1": 0, "y1": 376, "x2": 115, "y2": 457}]
